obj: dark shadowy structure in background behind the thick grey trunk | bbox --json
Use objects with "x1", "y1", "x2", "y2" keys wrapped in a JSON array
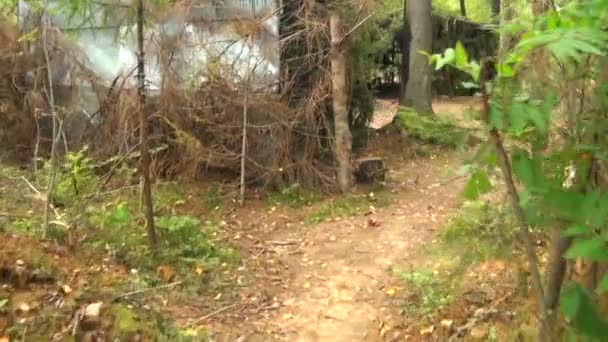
[{"x1": 374, "y1": 14, "x2": 498, "y2": 96}]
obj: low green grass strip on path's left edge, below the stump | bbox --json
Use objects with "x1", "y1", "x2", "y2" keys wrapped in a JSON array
[{"x1": 305, "y1": 190, "x2": 391, "y2": 224}]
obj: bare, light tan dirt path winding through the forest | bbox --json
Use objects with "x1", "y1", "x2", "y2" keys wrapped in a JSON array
[{"x1": 249, "y1": 154, "x2": 463, "y2": 342}]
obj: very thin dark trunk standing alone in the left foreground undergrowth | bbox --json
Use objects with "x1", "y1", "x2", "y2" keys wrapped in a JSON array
[{"x1": 137, "y1": 0, "x2": 157, "y2": 251}]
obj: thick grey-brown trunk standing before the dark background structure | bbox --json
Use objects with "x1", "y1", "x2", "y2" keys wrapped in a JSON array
[{"x1": 405, "y1": 0, "x2": 433, "y2": 114}]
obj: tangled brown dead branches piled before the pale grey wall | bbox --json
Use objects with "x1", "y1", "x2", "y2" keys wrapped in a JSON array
[{"x1": 0, "y1": 1, "x2": 334, "y2": 187}]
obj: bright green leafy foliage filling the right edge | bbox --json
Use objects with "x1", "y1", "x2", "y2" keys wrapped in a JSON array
[{"x1": 430, "y1": 0, "x2": 608, "y2": 341}]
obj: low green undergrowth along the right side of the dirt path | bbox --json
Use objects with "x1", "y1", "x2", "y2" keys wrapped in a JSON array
[{"x1": 391, "y1": 202, "x2": 515, "y2": 316}]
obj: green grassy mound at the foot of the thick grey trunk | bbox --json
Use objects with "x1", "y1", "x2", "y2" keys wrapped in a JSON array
[{"x1": 396, "y1": 107, "x2": 472, "y2": 147}]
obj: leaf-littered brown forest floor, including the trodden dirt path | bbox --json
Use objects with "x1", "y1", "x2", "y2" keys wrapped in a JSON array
[{"x1": 0, "y1": 95, "x2": 533, "y2": 342}]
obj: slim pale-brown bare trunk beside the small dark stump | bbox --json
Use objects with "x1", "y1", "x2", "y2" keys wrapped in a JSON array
[{"x1": 329, "y1": 9, "x2": 353, "y2": 191}]
